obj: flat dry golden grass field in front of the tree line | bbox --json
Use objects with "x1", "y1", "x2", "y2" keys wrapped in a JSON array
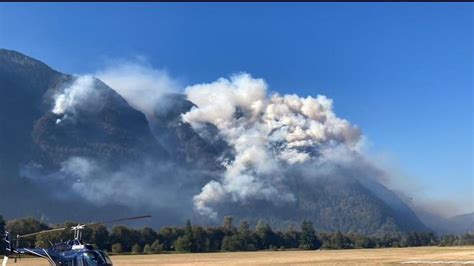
[{"x1": 10, "y1": 246, "x2": 474, "y2": 266}]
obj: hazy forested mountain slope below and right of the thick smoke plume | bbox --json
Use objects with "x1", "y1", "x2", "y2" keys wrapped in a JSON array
[{"x1": 211, "y1": 177, "x2": 429, "y2": 234}]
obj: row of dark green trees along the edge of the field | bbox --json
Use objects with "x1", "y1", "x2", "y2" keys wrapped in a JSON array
[{"x1": 0, "y1": 216, "x2": 474, "y2": 254}]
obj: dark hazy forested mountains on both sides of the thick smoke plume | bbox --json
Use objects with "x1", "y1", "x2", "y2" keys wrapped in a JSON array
[{"x1": 0, "y1": 49, "x2": 429, "y2": 234}]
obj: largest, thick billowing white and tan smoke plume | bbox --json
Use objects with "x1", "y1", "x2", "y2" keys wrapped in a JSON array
[{"x1": 182, "y1": 74, "x2": 362, "y2": 217}]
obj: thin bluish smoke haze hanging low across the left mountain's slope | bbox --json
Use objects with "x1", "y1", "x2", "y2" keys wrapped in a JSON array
[{"x1": 20, "y1": 156, "x2": 197, "y2": 212}]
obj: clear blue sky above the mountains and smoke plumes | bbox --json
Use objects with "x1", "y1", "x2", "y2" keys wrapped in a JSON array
[{"x1": 0, "y1": 3, "x2": 474, "y2": 215}]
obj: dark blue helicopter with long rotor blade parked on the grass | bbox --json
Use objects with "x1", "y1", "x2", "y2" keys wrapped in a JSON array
[{"x1": 2, "y1": 215, "x2": 151, "y2": 266}]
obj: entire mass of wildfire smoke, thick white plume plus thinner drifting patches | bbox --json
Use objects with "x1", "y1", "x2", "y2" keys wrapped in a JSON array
[{"x1": 26, "y1": 63, "x2": 462, "y2": 224}]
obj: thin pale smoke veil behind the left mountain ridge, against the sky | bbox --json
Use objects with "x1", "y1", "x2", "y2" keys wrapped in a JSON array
[{"x1": 96, "y1": 62, "x2": 180, "y2": 116}]
